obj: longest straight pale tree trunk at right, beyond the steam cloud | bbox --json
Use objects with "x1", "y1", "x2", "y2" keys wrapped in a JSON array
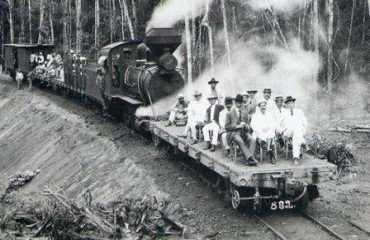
[{"x1": 327, "y1": 0, "x2": 334, "y2": 118}]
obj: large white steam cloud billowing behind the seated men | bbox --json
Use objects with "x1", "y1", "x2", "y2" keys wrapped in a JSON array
[{"x1": 137, "y1": 37, "x2": 320, "y2": 118}]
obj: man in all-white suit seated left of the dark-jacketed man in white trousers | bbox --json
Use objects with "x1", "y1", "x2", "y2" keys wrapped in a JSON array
[{"x1": 179, "y1": 90, "x2": 209, "y2": 144}]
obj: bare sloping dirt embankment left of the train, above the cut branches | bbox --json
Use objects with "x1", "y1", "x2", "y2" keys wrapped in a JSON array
[{"x1": 0, "y1": 79, "x2": 165, "y2": 202}]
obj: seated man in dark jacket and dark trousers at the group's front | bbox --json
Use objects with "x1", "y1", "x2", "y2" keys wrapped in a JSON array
[{"x1": 225, "y1": 94, "x2": 257, "y2": 166}]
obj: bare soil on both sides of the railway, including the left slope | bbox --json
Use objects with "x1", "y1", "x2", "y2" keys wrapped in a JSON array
[{"x1": 0, "y1": 76, "x2": 370, "y2": 239}]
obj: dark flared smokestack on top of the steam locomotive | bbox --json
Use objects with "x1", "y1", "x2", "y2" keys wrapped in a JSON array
[{"x1": 144, "y1": 28, "x2": 181, "y2": 58}]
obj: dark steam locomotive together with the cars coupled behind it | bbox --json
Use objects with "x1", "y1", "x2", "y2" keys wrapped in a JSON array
[{"x1": 4, "y1": 28, "x2": 184, "y2": 125}]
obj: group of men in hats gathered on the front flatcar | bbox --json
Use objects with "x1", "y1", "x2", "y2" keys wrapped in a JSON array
[{"x1": 167, "y1": 78, "x2": 307, "y2": 166}]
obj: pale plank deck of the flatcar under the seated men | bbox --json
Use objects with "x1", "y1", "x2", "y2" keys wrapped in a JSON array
[{"x1": 151, "y1": 121, "x2": 337, "y2": 188}]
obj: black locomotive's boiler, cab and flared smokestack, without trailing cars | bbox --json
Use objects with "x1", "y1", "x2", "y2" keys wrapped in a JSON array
[{"x1": 87, "y1": 28, "x2": 184, "y2": 109}]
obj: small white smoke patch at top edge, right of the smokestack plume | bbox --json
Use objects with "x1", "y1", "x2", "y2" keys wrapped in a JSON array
[{"x1": 246, "y1": 0, "x2": 311, "y2": 13}]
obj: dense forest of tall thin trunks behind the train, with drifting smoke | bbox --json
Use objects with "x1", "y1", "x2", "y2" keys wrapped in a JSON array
[{"x1": 0, "y1": 0, "x2": 370, "y2": 114}]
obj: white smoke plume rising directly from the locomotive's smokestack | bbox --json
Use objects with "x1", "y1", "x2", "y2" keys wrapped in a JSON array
[{"x1": 146, "y1": 0, "x2": 213, "y2": 30}]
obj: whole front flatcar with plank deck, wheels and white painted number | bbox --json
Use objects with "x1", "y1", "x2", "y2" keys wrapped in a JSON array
[{"x1": 150, "y1": 121, "x2": 337, "y2": 211}]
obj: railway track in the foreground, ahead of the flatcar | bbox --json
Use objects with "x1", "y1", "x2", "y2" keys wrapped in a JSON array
[{"x1": 254, "y1": 211, "x2": 346, "y2": 240}]
